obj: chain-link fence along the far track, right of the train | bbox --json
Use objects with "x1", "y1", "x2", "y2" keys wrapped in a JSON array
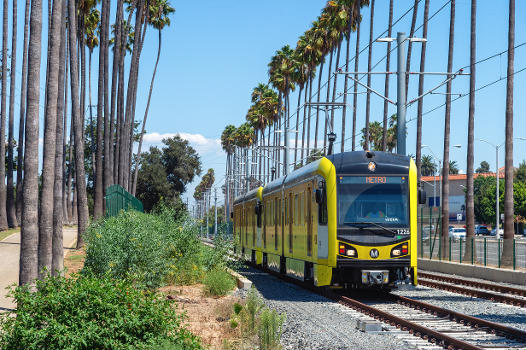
[{"x1": 418, "y1": 207, "x2": 526, "y2": 269}]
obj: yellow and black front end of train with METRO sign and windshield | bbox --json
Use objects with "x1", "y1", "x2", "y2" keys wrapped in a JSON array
[{"x1": 328, "y1": 152, "x2": 418, "y2": 287}]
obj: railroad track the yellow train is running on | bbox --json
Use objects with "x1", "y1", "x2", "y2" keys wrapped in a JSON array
[{"x1": 200, "y1": 241, "x2": 526, "y2": 350}]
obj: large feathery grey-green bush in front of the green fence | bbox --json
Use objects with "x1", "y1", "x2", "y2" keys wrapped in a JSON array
[{"x1": 84, "y1": 208, "x2": 201, "y2": 288}]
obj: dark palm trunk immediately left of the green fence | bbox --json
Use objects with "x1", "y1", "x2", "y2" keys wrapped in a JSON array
[{"x1": 92, "y1": 0, "x2": 109, "y2": 219}]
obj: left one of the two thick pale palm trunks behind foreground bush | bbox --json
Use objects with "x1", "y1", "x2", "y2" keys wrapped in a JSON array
[{"x1": 19, "y1": 0, "x2": 42, "y2": 285}]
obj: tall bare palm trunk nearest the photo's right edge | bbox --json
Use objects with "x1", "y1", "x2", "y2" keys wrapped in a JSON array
[{"x1": 502, "y1": 0, "x2": 515, "y2": 266}]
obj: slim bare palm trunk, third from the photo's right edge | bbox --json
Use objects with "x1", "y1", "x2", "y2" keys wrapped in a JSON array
[{"x1": 441, "y1": 0, "x2": 455, "y2": 258}]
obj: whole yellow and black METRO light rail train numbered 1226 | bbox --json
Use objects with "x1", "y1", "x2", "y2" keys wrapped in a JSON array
[{"x1": 232, "y1": 151, "x2": 425, "y2": 289}]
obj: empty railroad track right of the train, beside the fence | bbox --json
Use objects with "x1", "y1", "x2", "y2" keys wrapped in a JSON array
[{"x1": 418, "y1": 272, "x2": 526, "y2": 308}]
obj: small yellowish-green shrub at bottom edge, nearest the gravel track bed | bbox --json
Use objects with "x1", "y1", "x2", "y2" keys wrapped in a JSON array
[{"x1": 258, "y1": 307, "x2": 286, "y2": 350}]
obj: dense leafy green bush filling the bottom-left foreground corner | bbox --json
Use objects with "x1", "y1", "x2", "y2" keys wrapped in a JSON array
[{"x1": 0, "y1": 275, "x2": 201, "y2": 350}]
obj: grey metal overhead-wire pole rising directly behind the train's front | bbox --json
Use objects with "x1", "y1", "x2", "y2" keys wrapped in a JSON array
[{"x1": 396, "y1": 32, "x2": 407, "y2": 155}]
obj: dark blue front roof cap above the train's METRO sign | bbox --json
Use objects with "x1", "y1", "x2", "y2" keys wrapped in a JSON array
[{"x1": 327, "y1": 151, "x2": 411, "y2": 174}]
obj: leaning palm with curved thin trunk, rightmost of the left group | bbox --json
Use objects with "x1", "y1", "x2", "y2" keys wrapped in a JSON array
[{"x1": 131, "y1": 0, "x2": 175, "y2": 195}]
